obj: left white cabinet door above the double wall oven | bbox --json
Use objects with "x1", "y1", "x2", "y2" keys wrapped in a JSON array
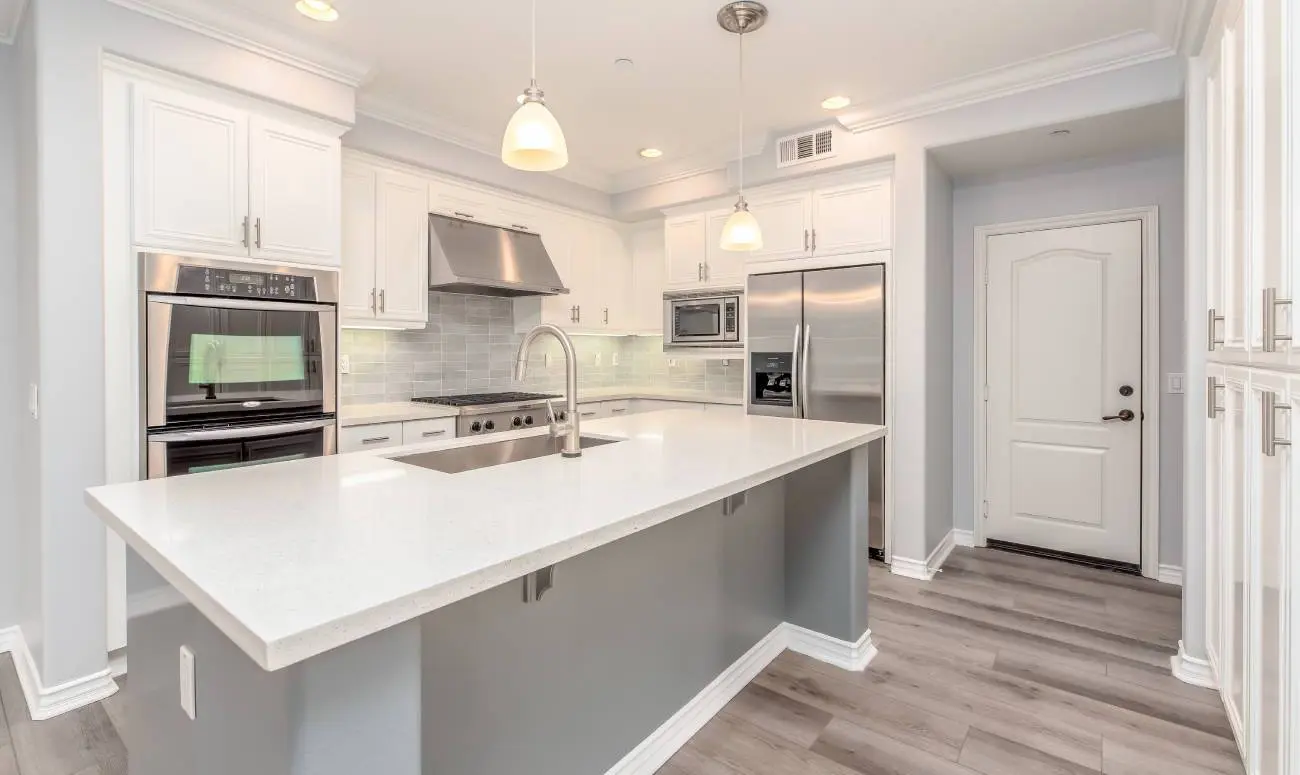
[{"x1": 131, "y1": 86, "x2": 248, "y2": 256}]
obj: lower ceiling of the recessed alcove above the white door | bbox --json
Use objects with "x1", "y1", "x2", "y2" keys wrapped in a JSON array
[{"x1": 931, "y1": 100, "x2": 1183, "y2": 179}]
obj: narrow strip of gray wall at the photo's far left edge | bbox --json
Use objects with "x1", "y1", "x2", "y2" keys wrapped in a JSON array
[{"x1": 0, "y1": 40, "x2": 22, "y2": 629}]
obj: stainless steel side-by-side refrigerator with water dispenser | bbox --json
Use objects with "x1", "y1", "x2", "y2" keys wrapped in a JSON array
[{"x1": 745, "y1": 264, "x2": 885, "y2": 555}]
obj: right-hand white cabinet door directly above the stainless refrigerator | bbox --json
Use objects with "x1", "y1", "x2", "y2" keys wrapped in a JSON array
[{"x1": 813, "y1": 179, "x2": 893, "y2": 256}]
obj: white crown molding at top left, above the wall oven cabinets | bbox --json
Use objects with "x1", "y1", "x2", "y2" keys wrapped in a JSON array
[{"x1": 108, "y1": 0, "x2": 373, "y2": 88}]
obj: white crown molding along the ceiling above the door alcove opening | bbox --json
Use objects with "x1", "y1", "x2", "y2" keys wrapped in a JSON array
[{"x1": 839, "y1": 30, "x2": 1180, "y2": 133}]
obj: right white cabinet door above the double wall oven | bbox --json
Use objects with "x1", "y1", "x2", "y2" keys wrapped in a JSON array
[{"x1": 248, "y1": 116, "x2": 341, "y2": 265}]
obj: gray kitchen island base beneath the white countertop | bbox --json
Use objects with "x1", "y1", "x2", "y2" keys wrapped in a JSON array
[{"x1": 126, "y1": 444, "x2": 883, "y2": 775}]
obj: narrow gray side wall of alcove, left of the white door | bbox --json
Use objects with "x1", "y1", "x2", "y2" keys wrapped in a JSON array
[{"x1": 913, "y1": 153, "x2": 953, "y2": 559}]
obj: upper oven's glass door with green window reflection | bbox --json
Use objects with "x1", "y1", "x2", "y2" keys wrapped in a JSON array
[{"x1": 146, "y1": 296, "x2": 337, "y2": 428}]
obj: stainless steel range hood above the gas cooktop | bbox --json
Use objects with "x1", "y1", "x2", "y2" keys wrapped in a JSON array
[{"x1": 429, "y1": 213, "x2": 568, "y2": 296}]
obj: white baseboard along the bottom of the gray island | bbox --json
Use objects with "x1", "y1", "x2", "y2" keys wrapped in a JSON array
[{"x1": 605, "y1": 622, "x2": 876, "y2": 775}]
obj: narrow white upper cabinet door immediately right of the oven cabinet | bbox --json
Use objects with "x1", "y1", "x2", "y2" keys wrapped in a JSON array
[{"x1": 339, "y1": 165, "x2": 378, "y2": 325}]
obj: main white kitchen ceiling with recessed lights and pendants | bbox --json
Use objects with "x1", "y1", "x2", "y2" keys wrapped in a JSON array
[{"x1": 205, "y1": 0, "x2": 1192, "y2": 190}]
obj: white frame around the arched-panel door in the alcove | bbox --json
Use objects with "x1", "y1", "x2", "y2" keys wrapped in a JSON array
[{"x1": 970, "y1": 205, "x2": 1164, "y2": 579}]
